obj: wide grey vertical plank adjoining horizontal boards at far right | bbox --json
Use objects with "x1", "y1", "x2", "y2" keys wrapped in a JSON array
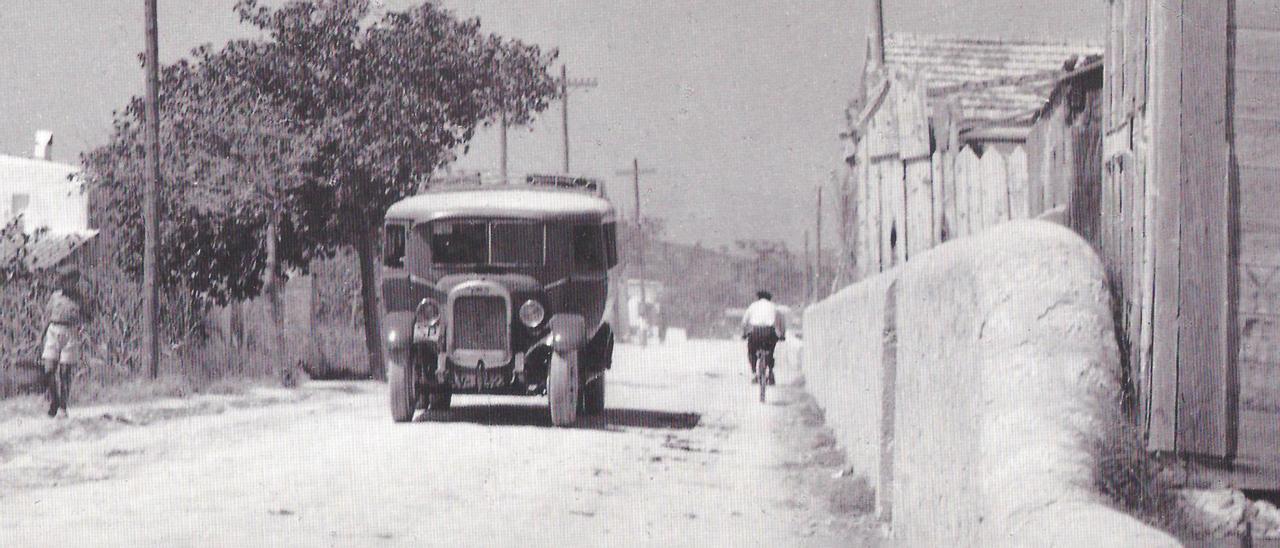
[{"x1": 1178, "y1": 1, "x2": 1233, "y2": 457}]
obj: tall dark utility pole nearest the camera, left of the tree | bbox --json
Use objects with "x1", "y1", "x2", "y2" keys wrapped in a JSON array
[{"x1": 142, "y1": 0, "x2": 160, "y2": 379}]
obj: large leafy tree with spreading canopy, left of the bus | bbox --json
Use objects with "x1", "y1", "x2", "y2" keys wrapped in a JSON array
[{"x1": 87, "y1": 0, "x2": 556, "y2": 378}]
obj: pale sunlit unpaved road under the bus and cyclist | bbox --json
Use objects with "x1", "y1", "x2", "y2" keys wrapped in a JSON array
[{"x1": 0, "y1": 342, "x2": 876, "y2": 547}]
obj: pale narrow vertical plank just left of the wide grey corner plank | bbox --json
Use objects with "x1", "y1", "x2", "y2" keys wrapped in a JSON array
[{"x1": 1147, "y1": 0, "x2": 1183, "y2": 451}]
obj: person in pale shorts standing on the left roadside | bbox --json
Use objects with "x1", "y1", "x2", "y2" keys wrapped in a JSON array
[{"x1": 40, "y1": 268, "x2": 87, "y2": 416}]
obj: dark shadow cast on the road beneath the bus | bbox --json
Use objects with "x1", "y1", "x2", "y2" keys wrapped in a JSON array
[{"x1": 416, "y1": 403, "x2": 701, "y2": 430}]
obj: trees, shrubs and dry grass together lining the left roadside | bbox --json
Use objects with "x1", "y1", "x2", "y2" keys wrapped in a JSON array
[{"x1": 0, "y1": 0, "x2": 557, "y2": 402}]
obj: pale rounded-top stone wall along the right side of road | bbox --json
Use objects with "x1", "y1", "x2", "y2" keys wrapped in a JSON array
[{"x1": 804, "y1": 222, "x2": 1176, "y2": 545}]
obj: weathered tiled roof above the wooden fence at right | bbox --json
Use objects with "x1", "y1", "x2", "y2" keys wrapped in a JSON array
[{"x1": 884, "y1": 33, "x2": 1102, "y2": 125}]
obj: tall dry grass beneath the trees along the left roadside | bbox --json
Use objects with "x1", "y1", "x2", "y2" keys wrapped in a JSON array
[{"x1": 0, "y1": 252, "x2": 369, "y2": 405}]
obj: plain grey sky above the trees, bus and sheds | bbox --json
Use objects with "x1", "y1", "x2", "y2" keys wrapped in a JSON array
[{"x1": 0, "y1": 0, "x2": 1106, "y2": 250}]
